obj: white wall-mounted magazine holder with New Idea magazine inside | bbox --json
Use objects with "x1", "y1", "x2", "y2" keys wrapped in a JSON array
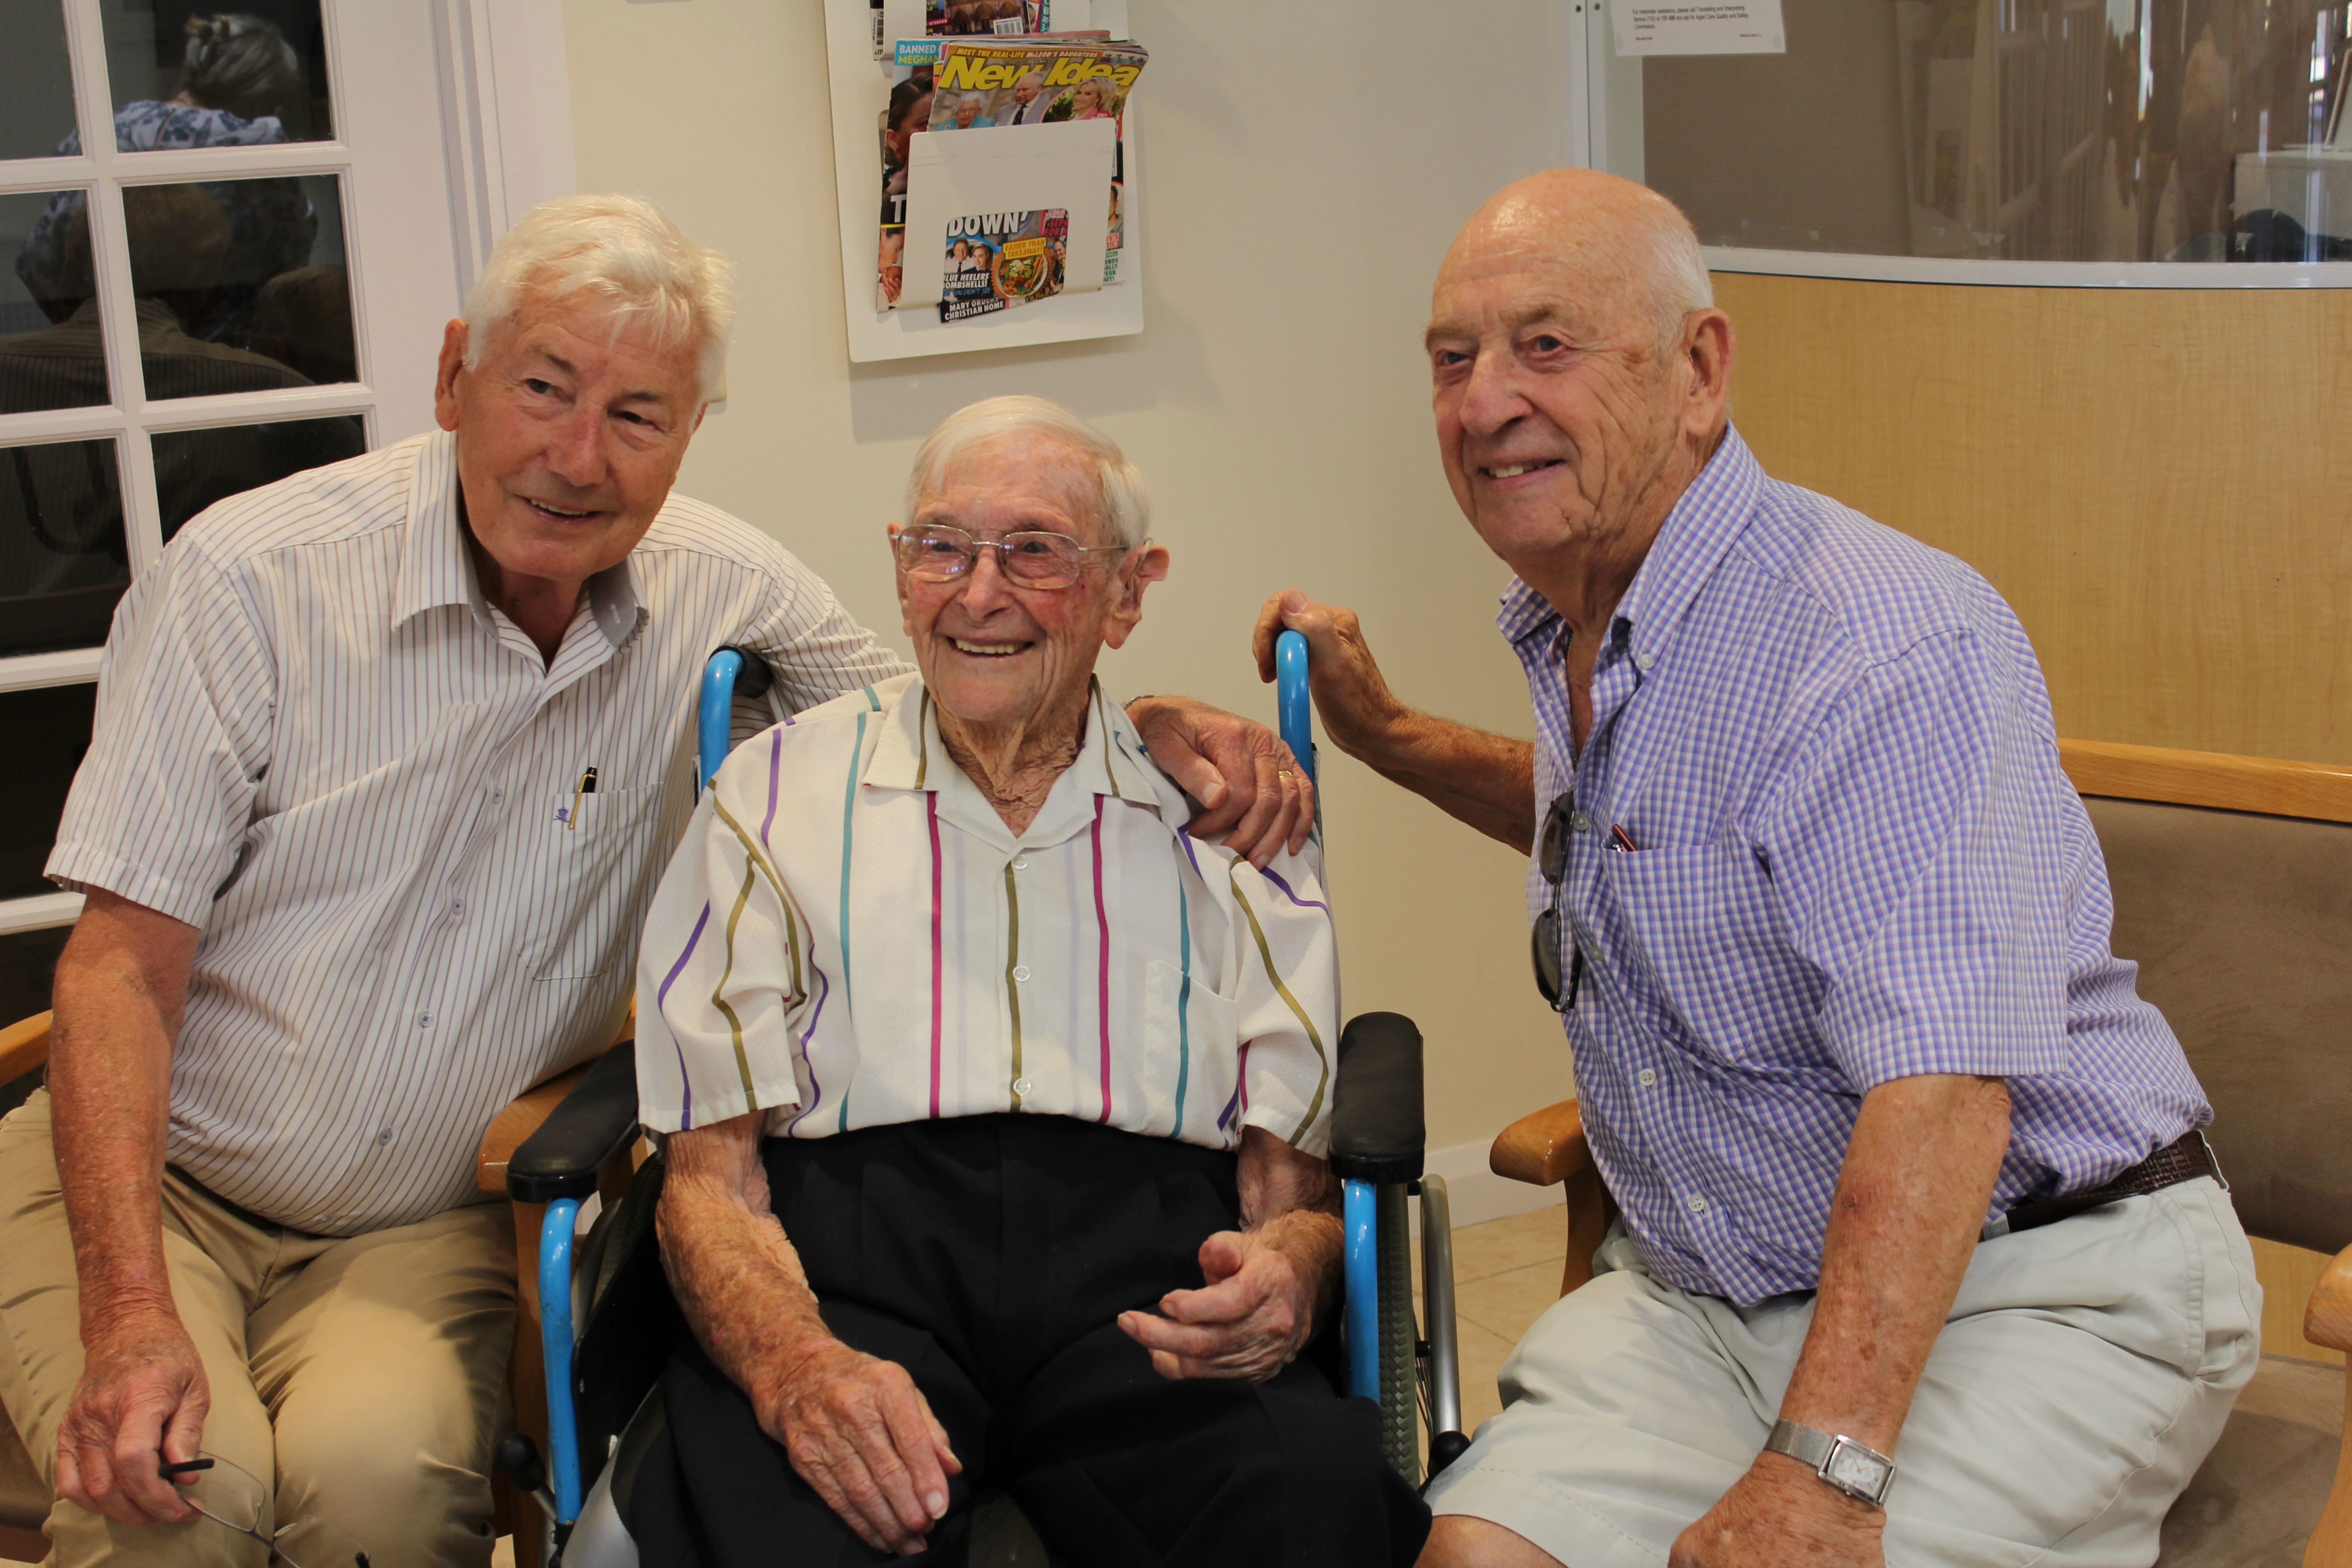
[{"x1": 826, "y1": 0, "x2": 1143, "y2": 364}]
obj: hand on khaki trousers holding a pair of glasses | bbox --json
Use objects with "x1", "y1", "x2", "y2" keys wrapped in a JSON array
[{"x1": 56, "y1": 1305, "x2": 212, "y2": 1526}]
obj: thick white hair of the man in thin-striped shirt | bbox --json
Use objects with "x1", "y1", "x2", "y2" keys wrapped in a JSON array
[{"x1": 466, "y1": 195, "x2": 734, "y2": 402}]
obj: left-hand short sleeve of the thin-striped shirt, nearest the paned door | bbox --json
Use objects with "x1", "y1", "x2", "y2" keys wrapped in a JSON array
[{"x1": 47, "y1": 539, "x2": 278, "y2": 926}]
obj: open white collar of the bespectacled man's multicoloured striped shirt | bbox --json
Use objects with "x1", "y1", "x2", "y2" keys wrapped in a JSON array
[{"x1": 858, "y1": 675, "x2": 1190, "y2": 846}]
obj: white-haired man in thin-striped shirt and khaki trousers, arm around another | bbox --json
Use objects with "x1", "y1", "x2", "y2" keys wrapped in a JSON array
[{"x1": 0, "y1": 197, "x2": 1310, "y2": 1568}]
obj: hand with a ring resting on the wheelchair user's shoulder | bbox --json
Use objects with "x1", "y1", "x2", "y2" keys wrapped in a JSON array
[{"x1": 1127, "y1": 696, "x2": 1315, "y2": 870}]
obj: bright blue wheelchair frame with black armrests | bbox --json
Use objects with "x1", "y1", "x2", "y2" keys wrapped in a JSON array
[{"x1": 499, "y1": 632, "x2": 1470, "y2": 1563}]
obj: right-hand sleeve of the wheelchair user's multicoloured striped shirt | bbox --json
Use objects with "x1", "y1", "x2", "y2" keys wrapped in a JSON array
[{"x1": 1228, "y1": 846, "x2": 1338, "y2": 1154}]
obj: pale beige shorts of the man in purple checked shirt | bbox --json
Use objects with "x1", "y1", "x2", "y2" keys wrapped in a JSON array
[{"x1": 1428, "y1": 1180, "x2": 2263, "y2": 1568}]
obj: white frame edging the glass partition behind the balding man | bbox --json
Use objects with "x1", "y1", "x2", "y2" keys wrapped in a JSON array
[{"x1": 1567, "y1": 0, "x2": 2352, "y2": 289}]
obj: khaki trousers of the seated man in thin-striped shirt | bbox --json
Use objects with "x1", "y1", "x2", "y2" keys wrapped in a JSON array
[{"x1": 0, "y1": 1091, "x2": 515, "y2": 1568}]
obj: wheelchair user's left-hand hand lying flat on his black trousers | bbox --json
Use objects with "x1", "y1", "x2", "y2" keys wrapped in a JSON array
[{"x1": 753, "y1": 1340, "x2": 964, "y2": 1556}]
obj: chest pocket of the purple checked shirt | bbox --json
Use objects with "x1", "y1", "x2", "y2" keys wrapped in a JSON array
[{"x1": 1602, "y1": 844, "x2": 1820, "y2": 1065}]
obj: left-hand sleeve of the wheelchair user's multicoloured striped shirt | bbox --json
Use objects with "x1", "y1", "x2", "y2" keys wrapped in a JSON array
[{"x1": 637, "y1": 752, "x2": 804, "y2": 1133}]
